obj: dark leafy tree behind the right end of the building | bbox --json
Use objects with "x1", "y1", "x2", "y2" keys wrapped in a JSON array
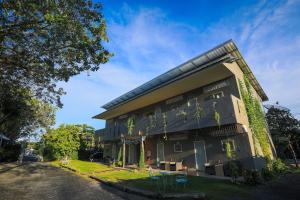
[{"x1": 266, "y1": 104, "x2": 300, "y2": 164}]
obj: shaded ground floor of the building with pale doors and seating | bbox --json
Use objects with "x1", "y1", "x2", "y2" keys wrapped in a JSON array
[{"x1": 103, "y1": 124, "x2": 261, "y2": 176}]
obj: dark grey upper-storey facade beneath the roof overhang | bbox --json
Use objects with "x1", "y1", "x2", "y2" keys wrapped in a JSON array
[{"x1": 104, "y1": 77, "x2": 239, "y2": 139}]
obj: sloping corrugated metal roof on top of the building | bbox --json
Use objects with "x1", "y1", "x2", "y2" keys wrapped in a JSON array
[{"x1": 102, "y1": 40, "x2": 268, "y2": 110}]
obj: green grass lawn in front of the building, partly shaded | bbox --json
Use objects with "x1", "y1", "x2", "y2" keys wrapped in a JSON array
[{"x1": 54, "y1": 160, "x2": 251, "y2": 199}]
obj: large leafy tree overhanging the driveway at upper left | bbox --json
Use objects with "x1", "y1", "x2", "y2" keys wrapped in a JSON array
[{"x1": 0, "y1": 0, "x2": 112, "y2": 140}]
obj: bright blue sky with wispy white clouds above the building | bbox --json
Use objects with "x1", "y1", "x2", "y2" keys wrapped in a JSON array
[{"x1": 56, "y1": 0, "x2": 300, "y2": 129}]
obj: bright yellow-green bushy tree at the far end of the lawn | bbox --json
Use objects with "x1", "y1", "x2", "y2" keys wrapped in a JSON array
[{"x1": 42, "y1": 124, "x2": 80, "y2": 160}]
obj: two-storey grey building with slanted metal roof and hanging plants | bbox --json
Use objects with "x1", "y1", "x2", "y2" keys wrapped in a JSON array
[{"x1": 94, "y1": 40, "x2": 274, "y2": 170}]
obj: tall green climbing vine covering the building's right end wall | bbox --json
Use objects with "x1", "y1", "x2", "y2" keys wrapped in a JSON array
[{"x1": 239, "y1": 76, "x2": 272, "y2": 158}]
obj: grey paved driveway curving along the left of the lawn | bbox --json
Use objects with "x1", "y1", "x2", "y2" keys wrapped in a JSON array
[{"x1": 0, "y1": 163, "x2": 150, "y2": 200}]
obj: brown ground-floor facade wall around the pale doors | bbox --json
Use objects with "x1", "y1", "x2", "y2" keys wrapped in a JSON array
[{"x1": 145, "y1": 133, "x2": 253, "y2": 169}]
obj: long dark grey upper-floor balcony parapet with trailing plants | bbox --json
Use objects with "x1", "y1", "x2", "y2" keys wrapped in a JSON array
[{"x1": 99, "y1": 95, "x2": 237, "y2": 140}]
